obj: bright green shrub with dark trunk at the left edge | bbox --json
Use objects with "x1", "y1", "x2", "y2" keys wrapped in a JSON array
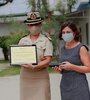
[{"x1": 0, "y1": 33, "x2": 27, "y2": 60}]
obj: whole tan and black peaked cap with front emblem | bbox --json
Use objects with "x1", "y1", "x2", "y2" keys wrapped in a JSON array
[{"x1": 24, "y1": 12, "x2": 44, "y2": 24}]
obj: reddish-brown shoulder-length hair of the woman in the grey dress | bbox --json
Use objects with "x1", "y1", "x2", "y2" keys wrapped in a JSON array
[{"x1": 59, "y1": 21, "x2": 80, "y2": 41}]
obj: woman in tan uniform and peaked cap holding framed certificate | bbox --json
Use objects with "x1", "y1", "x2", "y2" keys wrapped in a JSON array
[{"x1": 19, "y1": 12, "x2": 53, "y2": 100}]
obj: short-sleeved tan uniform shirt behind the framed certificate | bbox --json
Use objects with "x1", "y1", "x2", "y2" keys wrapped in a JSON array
[{"x1": 19, "y1": 34, "x2": 53, "y2": 62}]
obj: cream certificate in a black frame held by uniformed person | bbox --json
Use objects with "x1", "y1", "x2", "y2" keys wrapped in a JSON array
[{"x1": 10, "y1": 45, "x2": 37, "y2": 65}]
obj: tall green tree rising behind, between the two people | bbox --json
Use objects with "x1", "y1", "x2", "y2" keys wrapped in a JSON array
[{"x1": 29, "y1": 0, "x2": 66, "y2": 57}]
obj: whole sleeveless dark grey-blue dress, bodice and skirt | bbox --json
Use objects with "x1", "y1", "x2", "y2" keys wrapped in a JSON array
[{"x1": 60, "y1": 43, "x2": 90, "y2": 100}]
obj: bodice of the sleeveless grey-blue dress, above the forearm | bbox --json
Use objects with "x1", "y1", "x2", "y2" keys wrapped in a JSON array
[{"x1": 60, "y1": 44, "x2": 82, "y2": 65}]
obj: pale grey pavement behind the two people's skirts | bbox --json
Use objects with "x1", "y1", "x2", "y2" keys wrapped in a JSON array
[{"x1": 0, "y1": 74, "x2": 60, "y2": 100}]
